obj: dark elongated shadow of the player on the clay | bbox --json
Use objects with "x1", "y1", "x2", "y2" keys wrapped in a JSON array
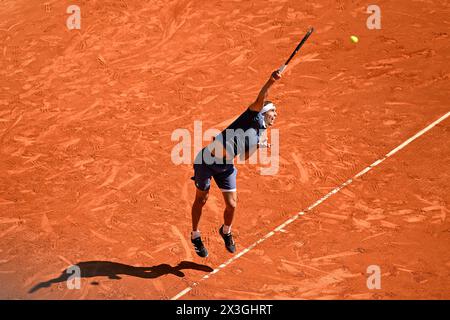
[{"x1": 28, "y1": 261, "x2": 213, "y2": 293}]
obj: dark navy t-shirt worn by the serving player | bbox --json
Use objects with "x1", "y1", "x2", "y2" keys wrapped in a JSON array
[{"x1": 215, "y1": 109, "x2": 266, "y2": 157}]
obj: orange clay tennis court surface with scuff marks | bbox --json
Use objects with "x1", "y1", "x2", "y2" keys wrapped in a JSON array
[{"x1": 0, "y1": 0, "x2": 450, "y2": 299}]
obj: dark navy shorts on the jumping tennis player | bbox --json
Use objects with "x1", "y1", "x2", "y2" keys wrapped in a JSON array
[{"x1": 191, "y1": 149, "x2": 237, "y2": 192}]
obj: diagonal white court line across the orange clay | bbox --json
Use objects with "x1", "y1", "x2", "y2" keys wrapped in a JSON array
[{"x1": 171, "y1": 111, "x2": 450, "y2": 300}]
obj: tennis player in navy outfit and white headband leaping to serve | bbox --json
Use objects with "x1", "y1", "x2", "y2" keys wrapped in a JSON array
[{"x1": 191, "y1": 70, "x2": 281, "y2": 257}]
